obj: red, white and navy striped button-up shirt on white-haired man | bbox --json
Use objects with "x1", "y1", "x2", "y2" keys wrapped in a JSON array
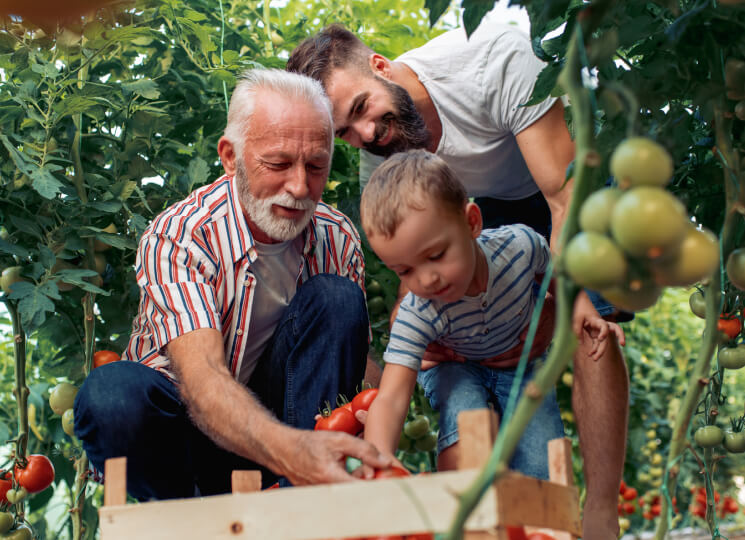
[{"x1": 122, "y1": 176, "x2": 364, "y2": 378}]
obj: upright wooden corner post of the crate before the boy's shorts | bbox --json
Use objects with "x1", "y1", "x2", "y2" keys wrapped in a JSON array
[{"x1": 458, "y1": 409, "x2": 498, "y2": 470}]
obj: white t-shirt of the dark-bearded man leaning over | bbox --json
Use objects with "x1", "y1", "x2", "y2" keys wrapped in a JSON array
[{"x1": 360, "y1": 15, "x2": 556, "y2": 200}]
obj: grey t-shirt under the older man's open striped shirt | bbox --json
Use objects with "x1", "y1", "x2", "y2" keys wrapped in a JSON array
[{"x1": 238, "y1": 237, "x2": 303, "y2": 384}]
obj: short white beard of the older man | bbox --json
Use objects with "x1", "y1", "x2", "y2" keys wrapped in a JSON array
[{"x1": 235, "y1": 158, "x2": 317, "y2": 242}]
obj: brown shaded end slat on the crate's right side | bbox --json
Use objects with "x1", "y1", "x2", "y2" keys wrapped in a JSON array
[{"x1": 496, "y1": 472, "x2": 582, "y2": 535}]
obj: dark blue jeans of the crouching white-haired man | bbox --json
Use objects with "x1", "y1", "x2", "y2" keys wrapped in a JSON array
[{"x1": 74, "y1": 274, "x2": 368, "y2": 500}]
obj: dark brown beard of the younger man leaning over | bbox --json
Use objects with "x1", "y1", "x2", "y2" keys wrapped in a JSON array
[{"x1": 364, "y1": 78, "x2": 430, "y2": 157}]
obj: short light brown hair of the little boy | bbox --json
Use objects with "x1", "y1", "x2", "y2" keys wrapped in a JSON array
[{"x1": 360, "y1": 150, "x2": 468, "y2": 238}]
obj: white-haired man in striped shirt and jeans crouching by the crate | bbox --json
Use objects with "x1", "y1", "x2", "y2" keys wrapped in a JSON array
[{"x1": 75, "y1": 70, "x2": 389, "y2": 500}]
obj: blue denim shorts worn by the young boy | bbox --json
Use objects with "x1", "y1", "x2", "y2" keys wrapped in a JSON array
[{"x1": 417, "y1": 356, "x2": 564, "y2": 480}]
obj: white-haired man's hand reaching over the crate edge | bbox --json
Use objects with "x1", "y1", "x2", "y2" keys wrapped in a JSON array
[{"x1": 275, "y1": 430, "x2": 393, "y2": 486}]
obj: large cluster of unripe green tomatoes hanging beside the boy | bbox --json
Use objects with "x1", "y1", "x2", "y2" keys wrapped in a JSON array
[{"x1": 564, "y1": 137, "x2": 719, "y2": 311}]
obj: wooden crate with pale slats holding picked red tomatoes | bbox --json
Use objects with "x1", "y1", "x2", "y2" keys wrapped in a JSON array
[{"x1": 99, "y1": 410, "x2": 581, "y2": 540}]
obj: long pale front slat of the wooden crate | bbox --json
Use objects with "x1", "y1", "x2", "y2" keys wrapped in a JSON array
[{"x1": 99, "y1": 470, "x2": 496, "y2": 540}]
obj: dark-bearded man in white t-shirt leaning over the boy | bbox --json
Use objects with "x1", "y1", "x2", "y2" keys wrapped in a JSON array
[{"x1": 287, "y1": 16, "x2": 628, "y2": 540}]
